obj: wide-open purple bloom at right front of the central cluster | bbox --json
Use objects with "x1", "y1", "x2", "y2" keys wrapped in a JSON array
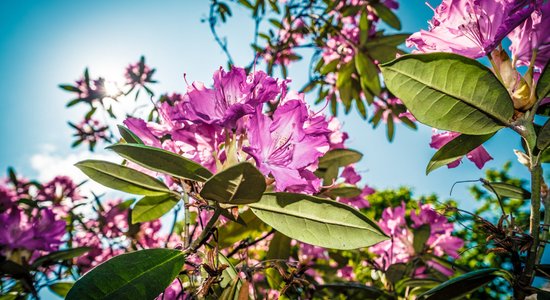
[{"x1": 243, "y1": 100, "x2": 329, "y2": 191}]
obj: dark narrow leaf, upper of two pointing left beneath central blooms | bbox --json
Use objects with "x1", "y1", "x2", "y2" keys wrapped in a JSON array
[{"x1": 107, "y1": 144, "x2": 212, "y2": 181}]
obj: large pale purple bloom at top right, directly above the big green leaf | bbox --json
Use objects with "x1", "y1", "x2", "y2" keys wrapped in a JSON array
[{"x1": 407, "y1": 0, "x2": 535, "y2": 58}]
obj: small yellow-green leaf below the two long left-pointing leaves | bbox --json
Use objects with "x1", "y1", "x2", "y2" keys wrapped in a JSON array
[{"x1": 132, "y1": 194, "x2": 179, "y2": 224}]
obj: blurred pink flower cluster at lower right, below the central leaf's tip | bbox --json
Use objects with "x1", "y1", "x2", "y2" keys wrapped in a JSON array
[{"x1": 369, "y1": 203, "x2": 464, "y2": 276}]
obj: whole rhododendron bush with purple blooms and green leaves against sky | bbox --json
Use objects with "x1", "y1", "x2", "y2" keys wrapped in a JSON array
[{"x1": 0, "y1": 0, "x2": 550, "y2": 299}]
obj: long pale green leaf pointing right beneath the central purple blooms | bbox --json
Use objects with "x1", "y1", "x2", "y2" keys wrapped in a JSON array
[{"x1": 250, "y1": 193, "x2": 388, "y2": 250}]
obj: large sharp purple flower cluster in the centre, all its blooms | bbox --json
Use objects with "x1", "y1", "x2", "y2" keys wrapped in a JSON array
[{"x1": 124, "y1": 67, "x2": 352, "y2": 193}]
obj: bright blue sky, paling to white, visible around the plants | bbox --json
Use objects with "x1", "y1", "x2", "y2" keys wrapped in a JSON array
[{"x1": 0, "y1": 0, "x2": 544, "y2": 298}]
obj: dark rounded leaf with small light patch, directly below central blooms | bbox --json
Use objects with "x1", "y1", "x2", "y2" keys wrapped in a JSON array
[{"x1": 200, "y1": 162, "x2": 266, "y2": 204}]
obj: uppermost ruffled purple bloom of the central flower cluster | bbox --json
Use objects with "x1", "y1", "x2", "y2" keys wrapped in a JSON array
[{"x1": 180, "y1": 67, "x2": 282, "y2": 128}]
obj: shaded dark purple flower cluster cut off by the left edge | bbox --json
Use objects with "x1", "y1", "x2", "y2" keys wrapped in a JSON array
[{"x1": 0, "y1": 175, "x2": 71, "y2": 264}]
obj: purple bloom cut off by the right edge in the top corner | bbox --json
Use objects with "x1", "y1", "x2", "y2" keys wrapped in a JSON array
[{"x1": 508, "y1": 2, "x2": 550, "y2": 69}]
